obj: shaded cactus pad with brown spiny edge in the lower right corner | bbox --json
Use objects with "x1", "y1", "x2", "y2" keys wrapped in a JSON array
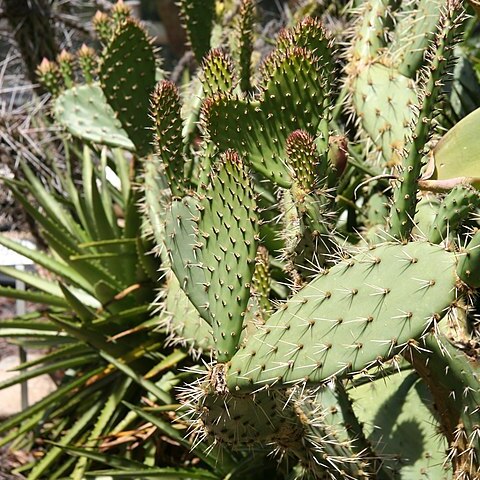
[{"x1": 406, "y1": 333, "x2": 480, "y2": 479}]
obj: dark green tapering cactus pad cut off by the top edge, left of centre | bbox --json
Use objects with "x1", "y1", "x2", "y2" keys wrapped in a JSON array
[{"x1": 179, "y1": 0, "x2": 215, "y2": 63}]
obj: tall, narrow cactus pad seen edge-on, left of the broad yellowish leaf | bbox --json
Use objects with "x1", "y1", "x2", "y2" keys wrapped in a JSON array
[{"x1": 389, "y1": 0, "x2": 464, "y2": 239}]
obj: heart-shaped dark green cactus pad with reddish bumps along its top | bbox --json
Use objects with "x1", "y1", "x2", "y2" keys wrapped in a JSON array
[{"x1": 202, "y1": 48, "x2": 328, "y2": 187}]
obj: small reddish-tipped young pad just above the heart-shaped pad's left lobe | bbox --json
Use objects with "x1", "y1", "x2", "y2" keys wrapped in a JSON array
[{"x1": 202, "y1": 48, "x2": 237, "y2": 97}]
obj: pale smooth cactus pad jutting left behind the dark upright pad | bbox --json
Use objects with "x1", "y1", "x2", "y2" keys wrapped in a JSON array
[{"x1": 53, "y1": 84, "x2": 135, "y2": 151}]
